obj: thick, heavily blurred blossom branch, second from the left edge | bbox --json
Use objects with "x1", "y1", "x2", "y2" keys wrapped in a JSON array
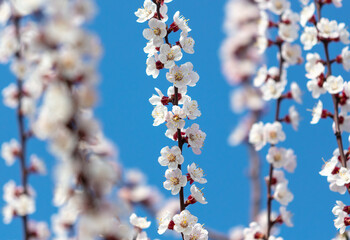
[{"x1": 32, "y1": 0, "x2": 133, "y2": 239}]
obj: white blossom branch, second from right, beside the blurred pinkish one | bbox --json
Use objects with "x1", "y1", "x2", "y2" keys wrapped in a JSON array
[{"x1": 243, "y1": 0, "x2": 303, "y2": 240}]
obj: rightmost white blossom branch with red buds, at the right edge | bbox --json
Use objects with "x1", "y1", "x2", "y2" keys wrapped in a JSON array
[{"x1": 300, "y1": 0, "x2": 350, "y2": 236}]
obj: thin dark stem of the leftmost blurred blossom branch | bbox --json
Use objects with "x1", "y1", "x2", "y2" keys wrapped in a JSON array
[{"x1": 13, "y1": 17, "x2": 29, "y2": 240}]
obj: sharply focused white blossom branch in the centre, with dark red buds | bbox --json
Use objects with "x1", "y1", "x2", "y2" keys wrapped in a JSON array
[{"x1": 135, "y1": 0, "x2": 208, "y2": 240}]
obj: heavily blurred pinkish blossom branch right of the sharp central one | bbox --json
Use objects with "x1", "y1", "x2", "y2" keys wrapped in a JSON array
[{"x1": 220, "y1": 0, "x2": 265, "y2": 222}]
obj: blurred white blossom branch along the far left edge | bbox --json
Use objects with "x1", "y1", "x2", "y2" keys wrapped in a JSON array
[{"x1": 0, "y1": 0, "x2": 50, "y2": 240}]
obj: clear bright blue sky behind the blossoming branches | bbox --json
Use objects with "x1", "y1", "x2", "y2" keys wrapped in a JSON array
[{"x1": 0, "y1": 0, "x2": 350, "y2": 240}]
